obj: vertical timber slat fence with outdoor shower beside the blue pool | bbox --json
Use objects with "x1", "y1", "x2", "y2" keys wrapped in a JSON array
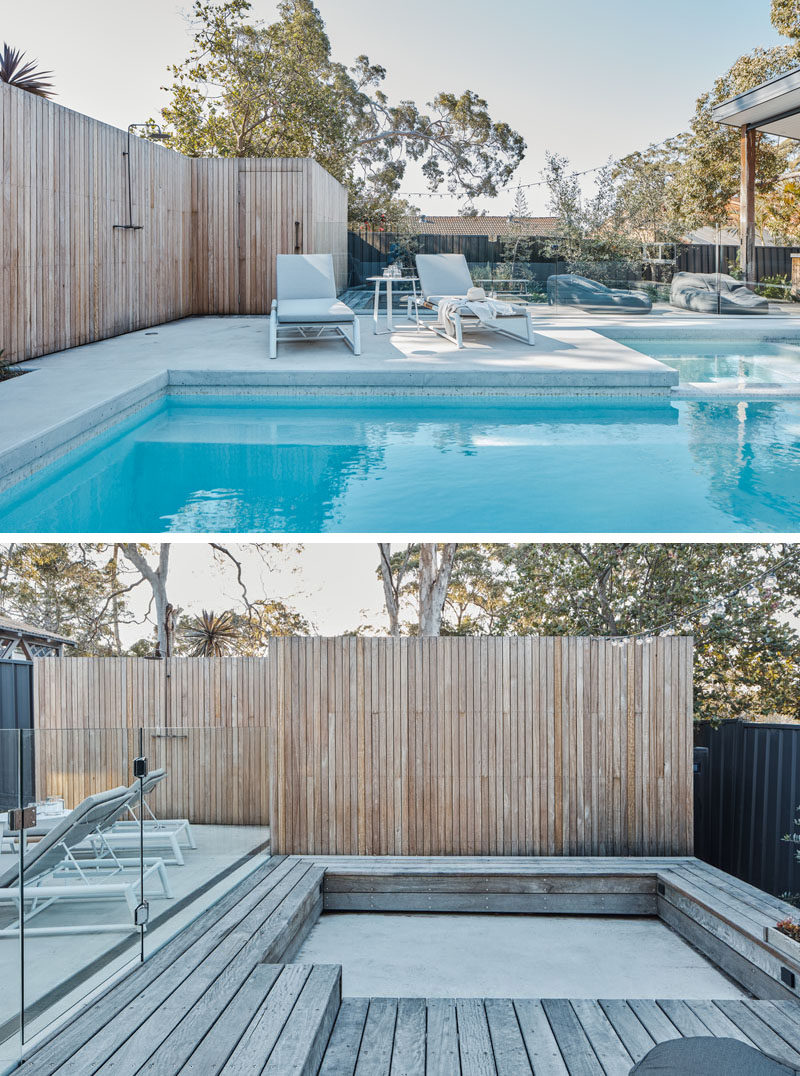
[{"x1": 0, "y1": 83, "x2": 347, "y2": 362}]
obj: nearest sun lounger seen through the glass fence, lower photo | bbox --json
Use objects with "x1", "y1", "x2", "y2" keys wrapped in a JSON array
[{"x1": 0, "y1": 787, "x2": 172, "y2": 937}]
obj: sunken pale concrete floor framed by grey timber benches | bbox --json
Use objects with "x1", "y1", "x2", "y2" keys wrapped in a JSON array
[{"x1": 294, "y1": 912, "x2": 747, "y2": 999}]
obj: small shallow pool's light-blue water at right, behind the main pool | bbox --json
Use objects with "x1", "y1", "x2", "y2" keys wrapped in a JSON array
[{"x1": 614, "y1": 336, "x2": 800, "y2": 387}]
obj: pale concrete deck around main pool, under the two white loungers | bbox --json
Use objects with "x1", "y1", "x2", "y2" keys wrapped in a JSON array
[{"x1": 0, "y1": 317, "x2": 677, "y2": 489}]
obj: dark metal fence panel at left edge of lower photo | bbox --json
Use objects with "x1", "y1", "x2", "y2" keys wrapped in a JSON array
[{"x1": 0, "y1": 661, "x2": 34, "y2": 810}]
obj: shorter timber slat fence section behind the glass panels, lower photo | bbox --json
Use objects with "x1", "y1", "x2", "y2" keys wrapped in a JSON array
[{"x1": 33, "y1": 657, "x2": 269, "y2": 825}]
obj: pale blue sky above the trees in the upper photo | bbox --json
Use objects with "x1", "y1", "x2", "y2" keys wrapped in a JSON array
[{"x1": 0, "y1": 0, "x2": 781, "y2": 213}]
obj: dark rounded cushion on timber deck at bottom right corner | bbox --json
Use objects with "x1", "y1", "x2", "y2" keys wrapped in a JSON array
[{"x1": 631, "y1": 1035, "x2": 798, "y2": 1076}]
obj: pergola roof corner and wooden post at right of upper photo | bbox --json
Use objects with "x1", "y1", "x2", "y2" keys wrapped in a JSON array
[{"x1": 712, "y1": 68, "x2": 800, "y2": 280}]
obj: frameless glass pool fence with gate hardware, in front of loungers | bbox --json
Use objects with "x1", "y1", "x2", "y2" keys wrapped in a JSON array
[{"x1": 0, "y1": 727, "x2": 269, "y2": 1067}]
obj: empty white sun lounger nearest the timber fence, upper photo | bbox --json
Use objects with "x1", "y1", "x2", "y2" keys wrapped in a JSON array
[{"x1": 269, "y1": 254, "x2": 361, "y2": 358}]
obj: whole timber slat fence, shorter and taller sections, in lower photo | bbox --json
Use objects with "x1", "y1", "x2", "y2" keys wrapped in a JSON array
[{"x1": 34, "y1": 637, "x2": 692, "y2": 855}]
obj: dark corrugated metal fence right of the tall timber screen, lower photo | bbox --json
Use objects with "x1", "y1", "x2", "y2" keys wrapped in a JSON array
[{"x1": 694, "y1": 721, "x2": 800, "y2": 896}]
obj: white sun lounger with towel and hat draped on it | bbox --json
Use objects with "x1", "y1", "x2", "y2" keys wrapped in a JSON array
[{"x1": 408, "y1": 254, "x2": 535, "y2": 348}]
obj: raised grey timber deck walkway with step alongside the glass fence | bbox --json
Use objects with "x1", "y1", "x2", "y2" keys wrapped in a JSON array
[{"x1": 17, "y1": 856, "x2": 325, "y2": 1076}]
